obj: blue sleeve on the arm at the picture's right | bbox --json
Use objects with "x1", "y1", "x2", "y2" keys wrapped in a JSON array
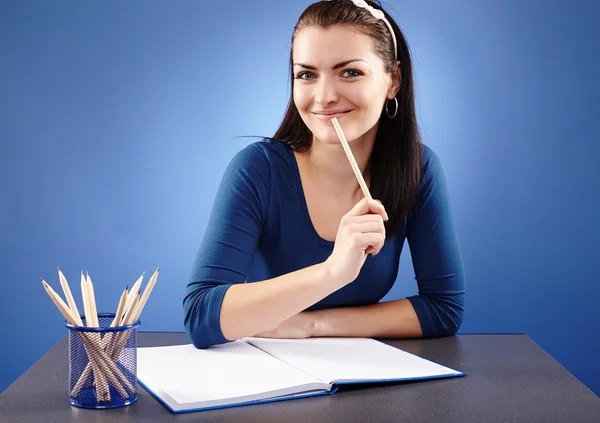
[{"x1": 406, "y1": 146, "x2": 465, "y2": 337}]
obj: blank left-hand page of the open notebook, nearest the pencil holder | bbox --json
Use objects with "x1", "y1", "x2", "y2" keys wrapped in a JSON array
[{"x1": 137, "y1": 341, "x2": 326, "y2": 407}]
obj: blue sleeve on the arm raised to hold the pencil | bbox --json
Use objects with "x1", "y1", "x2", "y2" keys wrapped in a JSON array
[{"x1": 183, "y1": 144, "x2": 270, "y2": 348}]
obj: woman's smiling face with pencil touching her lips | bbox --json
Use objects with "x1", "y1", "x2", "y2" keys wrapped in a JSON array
[{"x1": 292, "y1": 25, "x2": 398, "y2": 147}]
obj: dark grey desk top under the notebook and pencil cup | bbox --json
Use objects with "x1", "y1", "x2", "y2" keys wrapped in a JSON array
[{"x1": 0, "y1": 332, "x2": 600, "y2": 423}]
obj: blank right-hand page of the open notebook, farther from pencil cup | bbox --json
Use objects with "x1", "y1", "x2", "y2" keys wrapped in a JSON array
[{"x1": 246, "y1": 338, "x2": 462, "y2": 383}]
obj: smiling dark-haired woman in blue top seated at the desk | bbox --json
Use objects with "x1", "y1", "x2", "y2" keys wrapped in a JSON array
[{"x1": 184, "y1": 0, "x2": 465, "y2": 348}]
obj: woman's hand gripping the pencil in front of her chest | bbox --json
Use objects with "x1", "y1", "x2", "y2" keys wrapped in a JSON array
[{"x1": 325, "y1": 198, "x2": 388, "y2": 285}]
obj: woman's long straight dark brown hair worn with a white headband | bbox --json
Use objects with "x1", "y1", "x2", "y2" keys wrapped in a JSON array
[{"x1": 273, "y1": 0, "x2": 422, "y2": 236}]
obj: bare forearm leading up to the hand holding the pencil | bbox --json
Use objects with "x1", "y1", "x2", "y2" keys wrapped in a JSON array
[{"x1": 220, "y1": 263, "x2": 343, "y2": 340}]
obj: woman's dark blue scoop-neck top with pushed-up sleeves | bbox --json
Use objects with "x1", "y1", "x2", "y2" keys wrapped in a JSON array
[{"x1": 183, "y1": 139, "x2": 465, "y2": 348}]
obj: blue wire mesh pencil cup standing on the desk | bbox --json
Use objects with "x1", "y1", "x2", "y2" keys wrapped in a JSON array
[{"x1": 65, "y1": 313, "x2": 141, "y2": 409}]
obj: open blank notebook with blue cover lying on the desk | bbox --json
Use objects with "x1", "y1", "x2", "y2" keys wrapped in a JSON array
[{"x1": 137, "y1": 338, "x2": 466, "y2": 413}]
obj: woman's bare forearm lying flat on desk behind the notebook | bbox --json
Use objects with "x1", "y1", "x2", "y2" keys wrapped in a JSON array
[{"x1": 307, "y1": 298, "x2": 423, "y2": 338}]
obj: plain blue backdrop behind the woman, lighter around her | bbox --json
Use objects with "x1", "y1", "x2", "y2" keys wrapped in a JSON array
[{"x1": 0, "y1": 0, "x2": 600, "y2": 394}]
